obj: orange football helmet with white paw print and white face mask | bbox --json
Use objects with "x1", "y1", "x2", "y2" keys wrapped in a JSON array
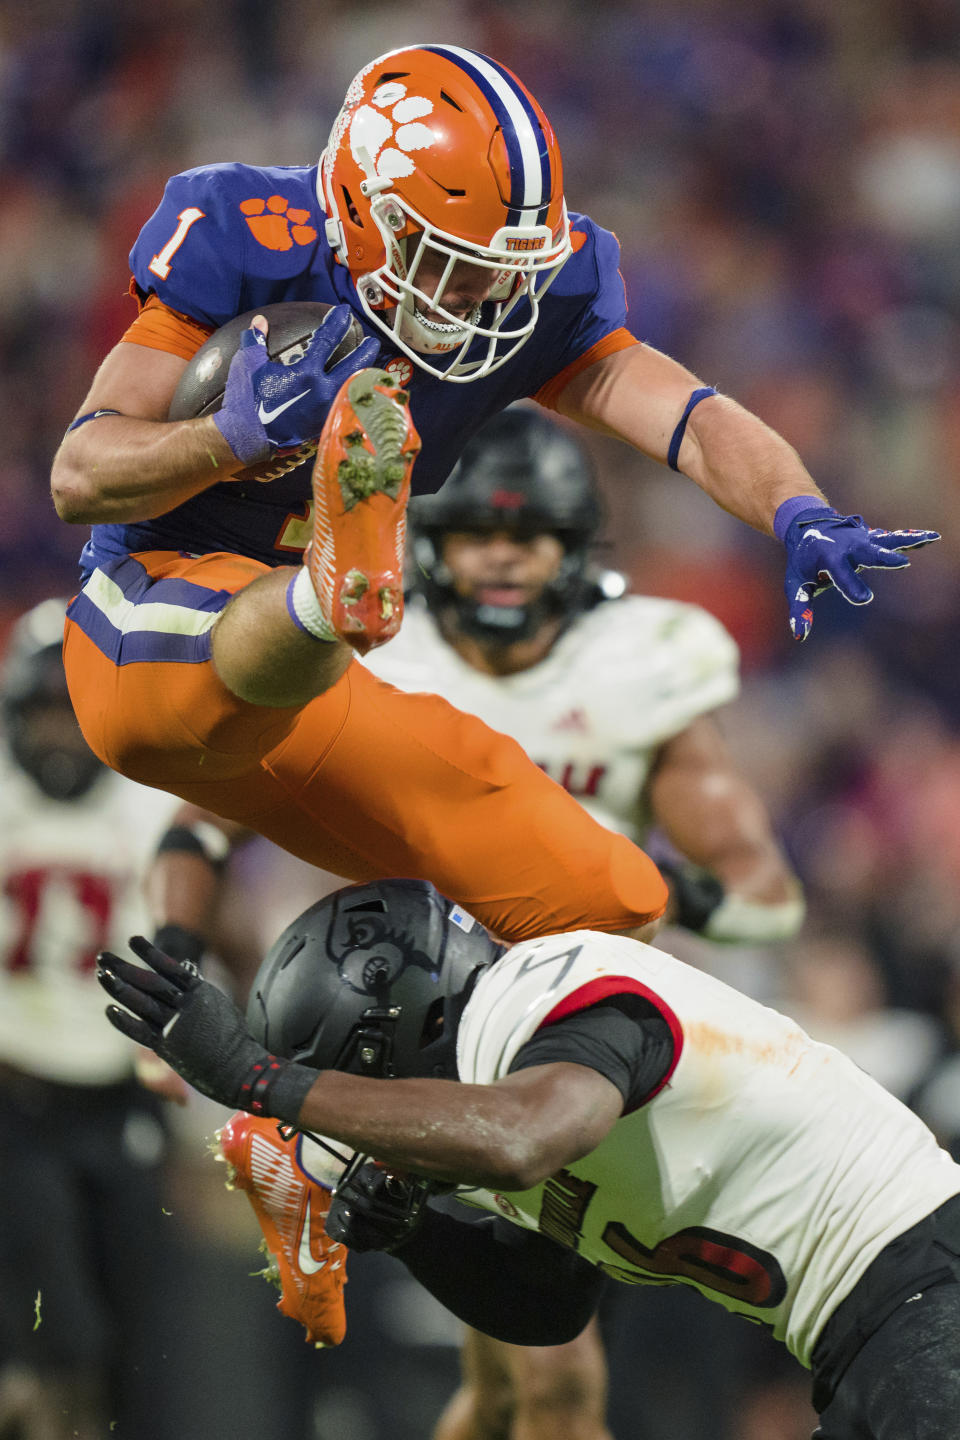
[{"x1": 317, "y1": 45, "x2": 571, "y2": 382}]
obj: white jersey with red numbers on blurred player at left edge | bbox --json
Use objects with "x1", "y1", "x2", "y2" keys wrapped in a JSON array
[{"x1": 0, "y1": 746, "x2": 178, "y2": 1084}]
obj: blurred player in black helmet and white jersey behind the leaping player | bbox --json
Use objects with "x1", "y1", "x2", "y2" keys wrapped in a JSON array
[{"x1": 366, "y1": 406, "x2": 803, "y2": 943}]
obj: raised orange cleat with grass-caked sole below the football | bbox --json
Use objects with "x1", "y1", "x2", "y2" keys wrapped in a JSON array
[{"x1": 304, "y1": 369, "x2": 420, "y2": 655}]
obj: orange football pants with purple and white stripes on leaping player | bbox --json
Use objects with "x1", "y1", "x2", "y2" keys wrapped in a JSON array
[{"x1": 63, "y1": 550, "x2": 666, "y2": 942}]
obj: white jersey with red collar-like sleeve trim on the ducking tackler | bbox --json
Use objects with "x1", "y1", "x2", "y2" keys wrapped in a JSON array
[{"x1": 458, "y1": 930, "x2": 960, "y2": 1367}]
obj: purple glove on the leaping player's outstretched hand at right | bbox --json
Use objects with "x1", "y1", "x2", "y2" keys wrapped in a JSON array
[{"x1": 773, "y1": 495, "x2": 940, "y2": 639}]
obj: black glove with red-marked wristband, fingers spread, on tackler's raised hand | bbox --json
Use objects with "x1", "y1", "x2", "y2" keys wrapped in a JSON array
[{"x1": 96, "y1": 935, "x2": 317, "y2": 1125}]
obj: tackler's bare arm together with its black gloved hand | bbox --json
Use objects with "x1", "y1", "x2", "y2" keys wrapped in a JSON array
[{"x1": 98, "y1": 936, "x2": 623, "y2": 1189}]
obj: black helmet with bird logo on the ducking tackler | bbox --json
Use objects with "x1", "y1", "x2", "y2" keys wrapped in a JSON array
[{"x1": 248, "y1": 880, "x2": 504, "y2": 1079}]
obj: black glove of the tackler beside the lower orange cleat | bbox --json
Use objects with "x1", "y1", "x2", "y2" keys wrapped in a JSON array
[{"x1": 324, "y1": 1155, "x2": 440, "y2": 1250}]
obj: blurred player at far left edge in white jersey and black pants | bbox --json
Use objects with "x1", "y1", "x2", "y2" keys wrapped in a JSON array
[{"x1": 0, "y1": 599, "x2": 174, "y2": 1440}]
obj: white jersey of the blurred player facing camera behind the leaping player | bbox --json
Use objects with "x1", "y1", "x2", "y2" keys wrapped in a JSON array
[{"x1": 364, "y1": 595, "x2": 738, "y2": 840}]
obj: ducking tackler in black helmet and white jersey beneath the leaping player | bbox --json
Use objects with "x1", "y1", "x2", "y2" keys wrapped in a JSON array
[{"x1": 101, "y1": 880, "x2": 960, "y2": 1440}]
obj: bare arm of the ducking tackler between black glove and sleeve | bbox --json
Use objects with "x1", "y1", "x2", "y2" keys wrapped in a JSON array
[{"x1": 298, "y1": 1064, "x2": 623, "y2": 1191}]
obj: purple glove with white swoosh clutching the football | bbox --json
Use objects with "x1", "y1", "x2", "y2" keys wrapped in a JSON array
[{"x1": 213, "y1": 305, "x2": 380, "y2": 465}]
